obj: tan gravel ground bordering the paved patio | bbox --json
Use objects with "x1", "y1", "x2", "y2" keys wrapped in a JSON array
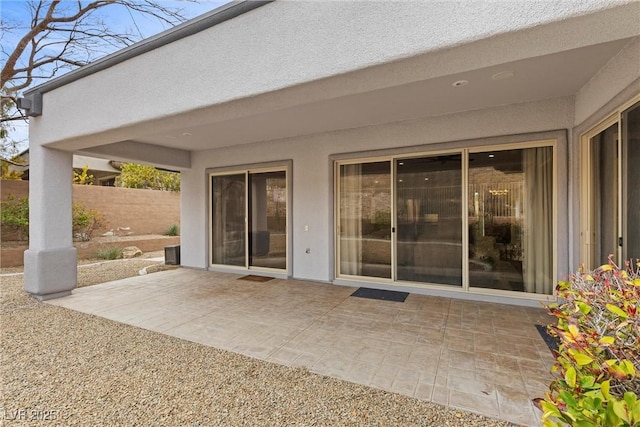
[{"x1": 0, "y1": 260, "x2": 511, "y2": 427}]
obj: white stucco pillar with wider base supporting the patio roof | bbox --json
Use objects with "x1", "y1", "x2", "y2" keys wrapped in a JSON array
[{"x1": 24, "y1": 143, "x2": 78, "y2": 300}]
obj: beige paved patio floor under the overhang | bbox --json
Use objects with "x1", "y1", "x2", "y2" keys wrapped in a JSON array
[{"x1": 48, "y1": 269, "x2": 553, "y2": 426}]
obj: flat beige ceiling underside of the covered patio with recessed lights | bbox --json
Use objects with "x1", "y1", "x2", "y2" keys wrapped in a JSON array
[{"x1": 126, "y1": 40, "x2": 629, "y2": 150}]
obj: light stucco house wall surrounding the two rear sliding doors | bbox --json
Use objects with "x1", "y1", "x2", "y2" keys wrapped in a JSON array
[{"x1": 181, "y1": 97, "x2": 573, "y2": 281}]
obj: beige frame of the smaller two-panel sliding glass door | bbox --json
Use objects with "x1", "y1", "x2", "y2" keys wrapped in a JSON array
[{"x1": 207, "y1": 165, "x2": 291, "y2": 277}]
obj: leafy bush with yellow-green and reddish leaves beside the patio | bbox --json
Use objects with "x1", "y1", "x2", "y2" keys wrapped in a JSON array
[{"x1": 536, "y1": 260, "x2": 640, "y2": 427}]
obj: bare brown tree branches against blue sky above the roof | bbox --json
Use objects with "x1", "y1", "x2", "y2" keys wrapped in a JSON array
[{"x1": 0, "y1": 0, "x2": 198, "y2": 160}]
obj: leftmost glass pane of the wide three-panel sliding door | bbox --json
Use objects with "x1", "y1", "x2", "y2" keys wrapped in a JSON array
[{"x1": 338, "y1": 161, "x2": 391, "y2": 279}]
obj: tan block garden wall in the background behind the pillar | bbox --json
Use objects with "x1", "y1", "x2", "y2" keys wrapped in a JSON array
[{"x1": 0, "y1": 181, "x2": 180, "y2": 240}]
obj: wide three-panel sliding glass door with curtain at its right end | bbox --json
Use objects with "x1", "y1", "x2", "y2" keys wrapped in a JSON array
[{"x1": 336, "y1": 141, "x2": 555, "y2": 295}]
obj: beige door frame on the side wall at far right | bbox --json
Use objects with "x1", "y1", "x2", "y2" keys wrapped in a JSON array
[{"x1": 580, "y1": 95, "x2": 640, "y2": 269}]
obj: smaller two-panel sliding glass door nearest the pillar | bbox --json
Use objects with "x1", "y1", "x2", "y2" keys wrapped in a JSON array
[{"x1": 211, "y1": 170, "x2": 288, "y2": 270}]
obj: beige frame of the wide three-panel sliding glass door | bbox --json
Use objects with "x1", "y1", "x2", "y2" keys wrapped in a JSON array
[{"x1": 333, "y1": 139, "x2": 559, "y2": 301}]
